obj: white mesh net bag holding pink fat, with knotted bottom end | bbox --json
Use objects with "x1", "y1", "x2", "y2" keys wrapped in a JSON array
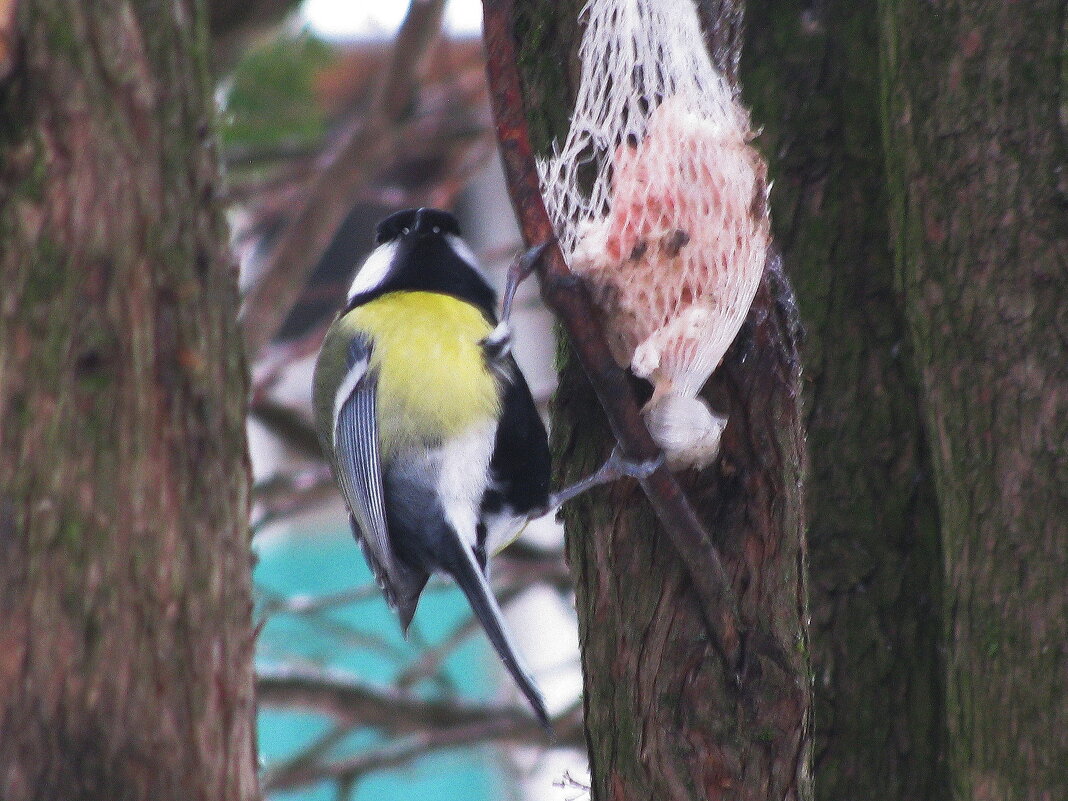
[{"x1": 538, "y1": 0, "x2": 770, "y2": 467}]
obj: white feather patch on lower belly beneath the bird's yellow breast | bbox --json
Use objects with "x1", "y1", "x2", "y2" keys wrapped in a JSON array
[{"x1": 438, "y1": 420, "x2": 497, "y2": 548}]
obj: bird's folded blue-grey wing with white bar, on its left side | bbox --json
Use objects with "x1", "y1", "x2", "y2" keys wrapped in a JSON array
[{"x1": 333, "y1": 336, "x2": 407, "y2": 607}]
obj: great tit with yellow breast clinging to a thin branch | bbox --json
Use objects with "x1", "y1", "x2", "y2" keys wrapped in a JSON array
[{"x1": 314, "y1": 208, "x2": 550, "y2": 726}]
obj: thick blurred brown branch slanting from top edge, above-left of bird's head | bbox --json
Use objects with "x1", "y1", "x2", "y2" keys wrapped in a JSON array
[{"x1": 241, "y1": 0, "x2": 444, "y2": 358}]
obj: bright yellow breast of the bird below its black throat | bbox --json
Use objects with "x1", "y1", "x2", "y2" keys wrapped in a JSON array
[{"x1": 343, "y1": 292, "x2": 501, "y2": 455}]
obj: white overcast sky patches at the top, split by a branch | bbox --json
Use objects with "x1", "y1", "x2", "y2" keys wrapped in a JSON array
[{"x1": 300, "y1": 0, "x2": 482, "y2": 38}]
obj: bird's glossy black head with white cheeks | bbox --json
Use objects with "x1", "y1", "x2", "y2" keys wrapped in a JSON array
[{"x1": 347, "y1": 208, "x2": 497, "y2": 323}]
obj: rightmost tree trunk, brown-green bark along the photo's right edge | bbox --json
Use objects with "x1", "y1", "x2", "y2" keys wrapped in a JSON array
[{"x1": 880, "y1": 0, "x2": 1068, "y2": 801}]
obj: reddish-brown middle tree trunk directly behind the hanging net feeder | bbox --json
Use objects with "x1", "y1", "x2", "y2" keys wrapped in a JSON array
[{"x1": 516, "y1": 0, "x2": 811, "y2": 800}]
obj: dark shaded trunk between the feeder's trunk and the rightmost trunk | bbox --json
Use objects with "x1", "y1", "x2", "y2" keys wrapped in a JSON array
[{"x1": 741, "y1": 0, "x2": 947, "y2": 801}]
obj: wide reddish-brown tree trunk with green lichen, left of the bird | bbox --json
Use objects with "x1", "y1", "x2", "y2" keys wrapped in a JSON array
[{"x1": 0, "y1": 0, "x2": 256, "y2": 801}]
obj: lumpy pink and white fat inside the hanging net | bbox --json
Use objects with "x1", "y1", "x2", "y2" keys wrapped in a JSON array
[{"x1": 571, "y1": 99, "x2": 769, "y2": 397}]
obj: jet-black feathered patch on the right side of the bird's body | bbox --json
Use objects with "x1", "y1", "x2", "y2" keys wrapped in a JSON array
[{"x1": 480, "y1": 357, "x2": 551, "y2": 523}]
